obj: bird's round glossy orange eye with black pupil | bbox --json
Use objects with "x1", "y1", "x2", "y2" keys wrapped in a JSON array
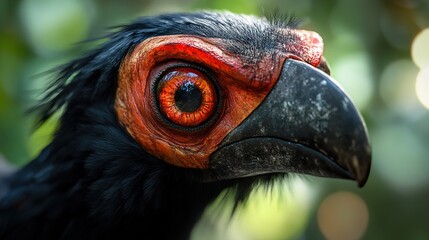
[{"x1": 156, "y1": 67, "x2": 217, "y2": 127}]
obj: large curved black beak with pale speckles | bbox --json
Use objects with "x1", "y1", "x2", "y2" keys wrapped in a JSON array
[{"x1": 210, "y1": 59, "x2": 371, "y2": 186}]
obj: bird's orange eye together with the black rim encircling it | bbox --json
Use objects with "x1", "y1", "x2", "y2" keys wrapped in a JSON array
[{"x1": 151, "y1": 62, "x2": 222, "y2": 132}]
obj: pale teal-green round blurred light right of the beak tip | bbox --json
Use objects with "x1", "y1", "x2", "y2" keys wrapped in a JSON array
[{"x1": 371, "y1": 122, "x2": 429, "y2": 192}]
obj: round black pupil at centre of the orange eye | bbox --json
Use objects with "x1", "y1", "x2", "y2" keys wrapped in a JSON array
[{"x1": 174, "y1": 81, "x2": 203, "y2": 112}]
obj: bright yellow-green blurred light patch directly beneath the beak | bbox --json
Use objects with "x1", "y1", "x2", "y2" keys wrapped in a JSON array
[{"x1": 234, "y1": 178, "x2": 314, "y2": 240}]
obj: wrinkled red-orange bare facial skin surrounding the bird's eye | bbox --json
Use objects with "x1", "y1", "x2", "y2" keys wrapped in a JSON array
[{"x1": 115, "y1": 30, "x2": 323, "y2": 169}]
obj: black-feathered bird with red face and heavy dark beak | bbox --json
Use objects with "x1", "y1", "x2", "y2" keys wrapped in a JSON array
[{"x1": 0, "y1": 11, "x2": 371, "y2": 239}]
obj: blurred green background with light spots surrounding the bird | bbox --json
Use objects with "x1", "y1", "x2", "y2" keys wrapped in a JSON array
[{"x1": 0, "y1": 0, "x2": 429, "y2": 240}]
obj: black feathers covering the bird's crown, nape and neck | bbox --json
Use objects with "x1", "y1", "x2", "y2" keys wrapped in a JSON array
[{"x1": 0, "y1": 12, "x2": 296, "y2": 239}]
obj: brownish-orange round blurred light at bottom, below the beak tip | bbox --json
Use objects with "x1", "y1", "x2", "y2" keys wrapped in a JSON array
[{"x1": 317, "y1": 192, "x2": 369, "y2": 240}]
